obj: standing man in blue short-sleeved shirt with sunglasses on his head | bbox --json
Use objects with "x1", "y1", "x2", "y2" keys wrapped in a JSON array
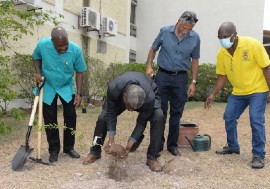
[{"x1": 146, "y1": 11, "x2": 200, "y2": 156}]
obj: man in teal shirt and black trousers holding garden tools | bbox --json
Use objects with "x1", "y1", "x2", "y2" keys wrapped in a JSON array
[{"x1": 33, "y1": 27, "x2": 87, "y2": 163}]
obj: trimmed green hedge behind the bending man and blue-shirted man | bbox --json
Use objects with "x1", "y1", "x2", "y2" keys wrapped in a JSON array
[{"x1": 85, "y1": 58, "x2": 232, "y2": 102}]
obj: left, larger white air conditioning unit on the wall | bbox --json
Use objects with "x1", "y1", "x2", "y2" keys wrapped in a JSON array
[{"x1": 80, "y1": 7, "x2": 100, "y2": 30}]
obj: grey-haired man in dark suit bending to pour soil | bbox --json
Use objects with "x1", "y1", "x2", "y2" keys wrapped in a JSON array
[{"x1": 83, "y1": 72, "x2": 165, "y2": 171}]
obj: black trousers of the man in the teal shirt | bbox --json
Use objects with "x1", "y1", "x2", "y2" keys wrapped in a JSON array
[{"x1": 43, "y1": 94, "x2": 77, "y2": 153}]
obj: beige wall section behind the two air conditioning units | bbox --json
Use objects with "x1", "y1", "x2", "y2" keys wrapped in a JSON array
[{"x1": 5, "y1": 0, "x2": 129, "y2": 62}]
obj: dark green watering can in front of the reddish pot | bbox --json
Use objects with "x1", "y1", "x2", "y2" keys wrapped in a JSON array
[{"x1": 185, "y1": 134, "x2": 211, "y2": 152}]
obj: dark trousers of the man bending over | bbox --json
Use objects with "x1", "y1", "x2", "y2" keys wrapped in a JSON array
[{"x1": 90, "y1": 100, "x2": 165, "y2": 160}]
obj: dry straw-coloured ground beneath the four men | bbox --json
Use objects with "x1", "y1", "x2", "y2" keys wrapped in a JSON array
[{"x1": 0, "y1": 102, "x2": 270, "y2": 189}]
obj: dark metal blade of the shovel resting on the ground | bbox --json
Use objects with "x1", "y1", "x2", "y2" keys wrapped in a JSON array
[{"x1": 11, "y1": 145, "x2": 34, "y2": 171}]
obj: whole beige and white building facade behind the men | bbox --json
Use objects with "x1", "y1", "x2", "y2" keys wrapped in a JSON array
[{"x1": 4, "y1": 0, "x2": 265, "y2": 64}]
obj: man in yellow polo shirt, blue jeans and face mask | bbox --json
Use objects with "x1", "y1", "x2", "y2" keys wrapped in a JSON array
[{"x1": 204, "y1": 22, "x2": 270, "y2": 169}]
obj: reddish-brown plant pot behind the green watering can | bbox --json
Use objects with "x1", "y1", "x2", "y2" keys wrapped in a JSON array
[{"x1": 178, "y1": 124, "x2": 199, "y2": 148}]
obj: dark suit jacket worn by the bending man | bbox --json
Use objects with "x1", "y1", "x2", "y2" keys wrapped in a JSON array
[{"x1": 106, "y1": 72, "x2": 161, "y2": 141}]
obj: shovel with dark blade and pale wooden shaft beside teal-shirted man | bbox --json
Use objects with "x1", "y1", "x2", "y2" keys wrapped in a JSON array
[{"x1": 11, "y1": 81, "x2": 44, "y2": 171}]
